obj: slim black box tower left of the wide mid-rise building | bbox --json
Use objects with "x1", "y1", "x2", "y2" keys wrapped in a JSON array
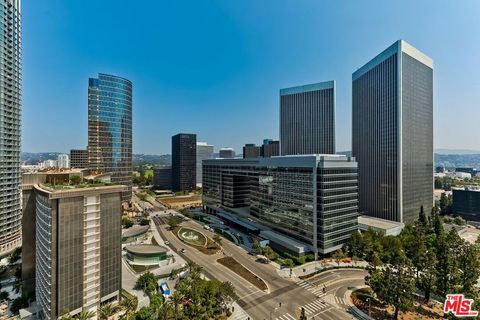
[{"x1": 172, "y1": 133, "x2": 197, "y2": 191}]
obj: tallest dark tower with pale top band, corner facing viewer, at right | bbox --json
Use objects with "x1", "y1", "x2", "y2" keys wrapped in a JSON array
[{"x1": 352, "y1": 40, "x2": 433, "y2": 223}]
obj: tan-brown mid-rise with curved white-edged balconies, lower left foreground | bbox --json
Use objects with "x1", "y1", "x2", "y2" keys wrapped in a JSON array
[{"x1": 22, "y1": 174, "x2": 127, "y2": 319}]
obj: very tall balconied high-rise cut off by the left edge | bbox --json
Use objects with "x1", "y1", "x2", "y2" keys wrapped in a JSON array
[{"x1": 0, "y1": 0, "x2": 22, "y2": 256}]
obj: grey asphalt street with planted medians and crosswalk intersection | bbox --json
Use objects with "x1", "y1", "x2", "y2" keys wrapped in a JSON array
[{"x1": 152, "y1": 210, "x2": 365, "y2": 320}]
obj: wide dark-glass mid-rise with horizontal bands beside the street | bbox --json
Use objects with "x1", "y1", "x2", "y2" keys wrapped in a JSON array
[{"x1": 203, "y1": 155, "x2": 358, "y2": 255}]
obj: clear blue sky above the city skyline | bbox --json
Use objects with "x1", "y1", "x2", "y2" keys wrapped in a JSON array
[{"x1": 22, "y1": 0, "x2": 480, "y2": 154}]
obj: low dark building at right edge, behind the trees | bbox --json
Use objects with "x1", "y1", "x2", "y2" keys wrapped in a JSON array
[{"x1": 452, "y1": 188, "x2": 480, "y2": 222}]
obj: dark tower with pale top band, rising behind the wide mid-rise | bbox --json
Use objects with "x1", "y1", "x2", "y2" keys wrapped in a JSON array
[{"x1": 280, "y1": 81, "x2": 335, "y2": 155}]
